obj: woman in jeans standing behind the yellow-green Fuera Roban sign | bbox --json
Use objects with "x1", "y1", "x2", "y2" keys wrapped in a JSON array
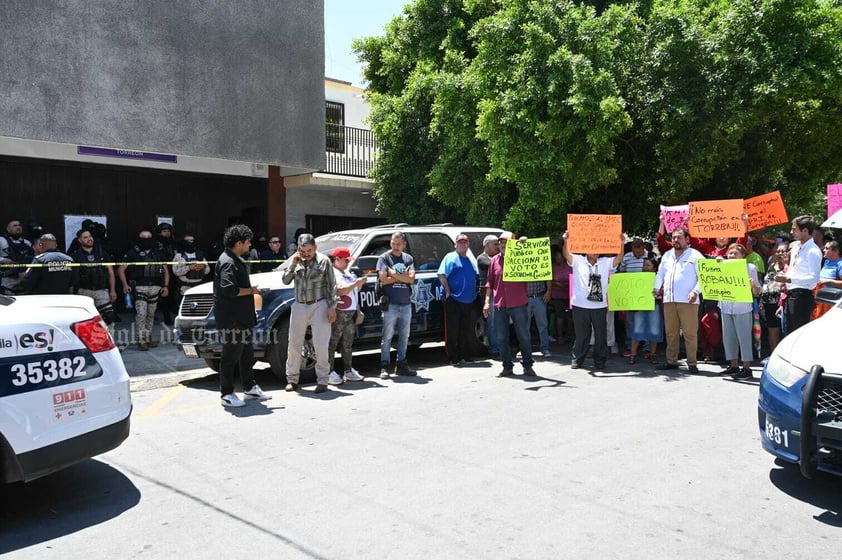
[{"x1": 716, "y1": 243, "x2": 760, "y2": 379}]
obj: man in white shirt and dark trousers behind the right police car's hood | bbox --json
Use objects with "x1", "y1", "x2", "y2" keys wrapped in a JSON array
[{"x1": 775, "y1": 215, "x2": 822, "y2": 336}]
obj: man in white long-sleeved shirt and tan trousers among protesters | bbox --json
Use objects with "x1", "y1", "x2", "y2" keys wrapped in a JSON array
[{"x1": 653, "y1": 227, "x2": 704, "y2": 373}]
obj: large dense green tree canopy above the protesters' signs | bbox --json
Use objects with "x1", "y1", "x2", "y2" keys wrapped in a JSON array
[{"x1": 354, "y1": 0, "x2": 842, "y2": 235}]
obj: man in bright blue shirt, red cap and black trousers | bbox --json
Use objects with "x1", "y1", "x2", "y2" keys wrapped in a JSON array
[{"x1": 438, "y1": 233, "x2": 479, "y2": 366}]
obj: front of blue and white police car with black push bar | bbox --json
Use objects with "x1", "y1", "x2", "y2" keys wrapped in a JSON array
[{"x1": 757, "y1": 288, "x2": 842, "y2": 478}]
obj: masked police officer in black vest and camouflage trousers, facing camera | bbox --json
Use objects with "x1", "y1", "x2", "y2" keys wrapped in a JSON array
[{"x1": 117, "y1": 229, "x2": 170, "y2": 350}]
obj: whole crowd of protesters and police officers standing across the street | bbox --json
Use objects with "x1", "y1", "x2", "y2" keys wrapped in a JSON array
[{"x1": 0, "y1": 211, "x2": 842, "y2": 406}]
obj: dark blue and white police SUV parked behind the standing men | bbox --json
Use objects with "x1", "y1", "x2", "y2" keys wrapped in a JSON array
[{"x1": 175, "y1": 224, "x2": 502, "y2": 380}]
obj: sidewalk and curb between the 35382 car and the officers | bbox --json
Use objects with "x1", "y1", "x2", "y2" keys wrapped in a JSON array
[{"x1": 112, "y1": 312, "x2": 214, "y2": 391}]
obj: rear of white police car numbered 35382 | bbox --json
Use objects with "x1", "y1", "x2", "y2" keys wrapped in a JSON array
[{"x1": 0, "y1": 295, "x2": 132, "y2": 482}]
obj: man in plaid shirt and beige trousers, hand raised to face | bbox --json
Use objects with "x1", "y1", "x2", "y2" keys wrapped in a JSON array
[{"x1": 281, "y1": 233, "x2": 337, "y2": 393}]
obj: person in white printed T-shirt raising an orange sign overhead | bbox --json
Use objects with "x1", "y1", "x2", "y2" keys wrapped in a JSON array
[{"x1": 561, "y1": 231, "x2": 624, "y2": 369}]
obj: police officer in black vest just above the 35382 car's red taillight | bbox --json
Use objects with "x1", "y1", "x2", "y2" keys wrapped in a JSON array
[{"x1": 70, "y1": 229, "x2": 117, "y2": 325}]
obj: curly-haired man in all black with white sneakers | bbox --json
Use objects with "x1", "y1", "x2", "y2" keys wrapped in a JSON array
[{"x1": 213, "y1": 224, "x2": 272, "y2": 407}]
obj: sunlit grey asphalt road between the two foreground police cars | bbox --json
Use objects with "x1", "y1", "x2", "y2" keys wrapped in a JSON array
[{"x1": 0, "y1": 347, "x2": 842, "y2": 560}]
